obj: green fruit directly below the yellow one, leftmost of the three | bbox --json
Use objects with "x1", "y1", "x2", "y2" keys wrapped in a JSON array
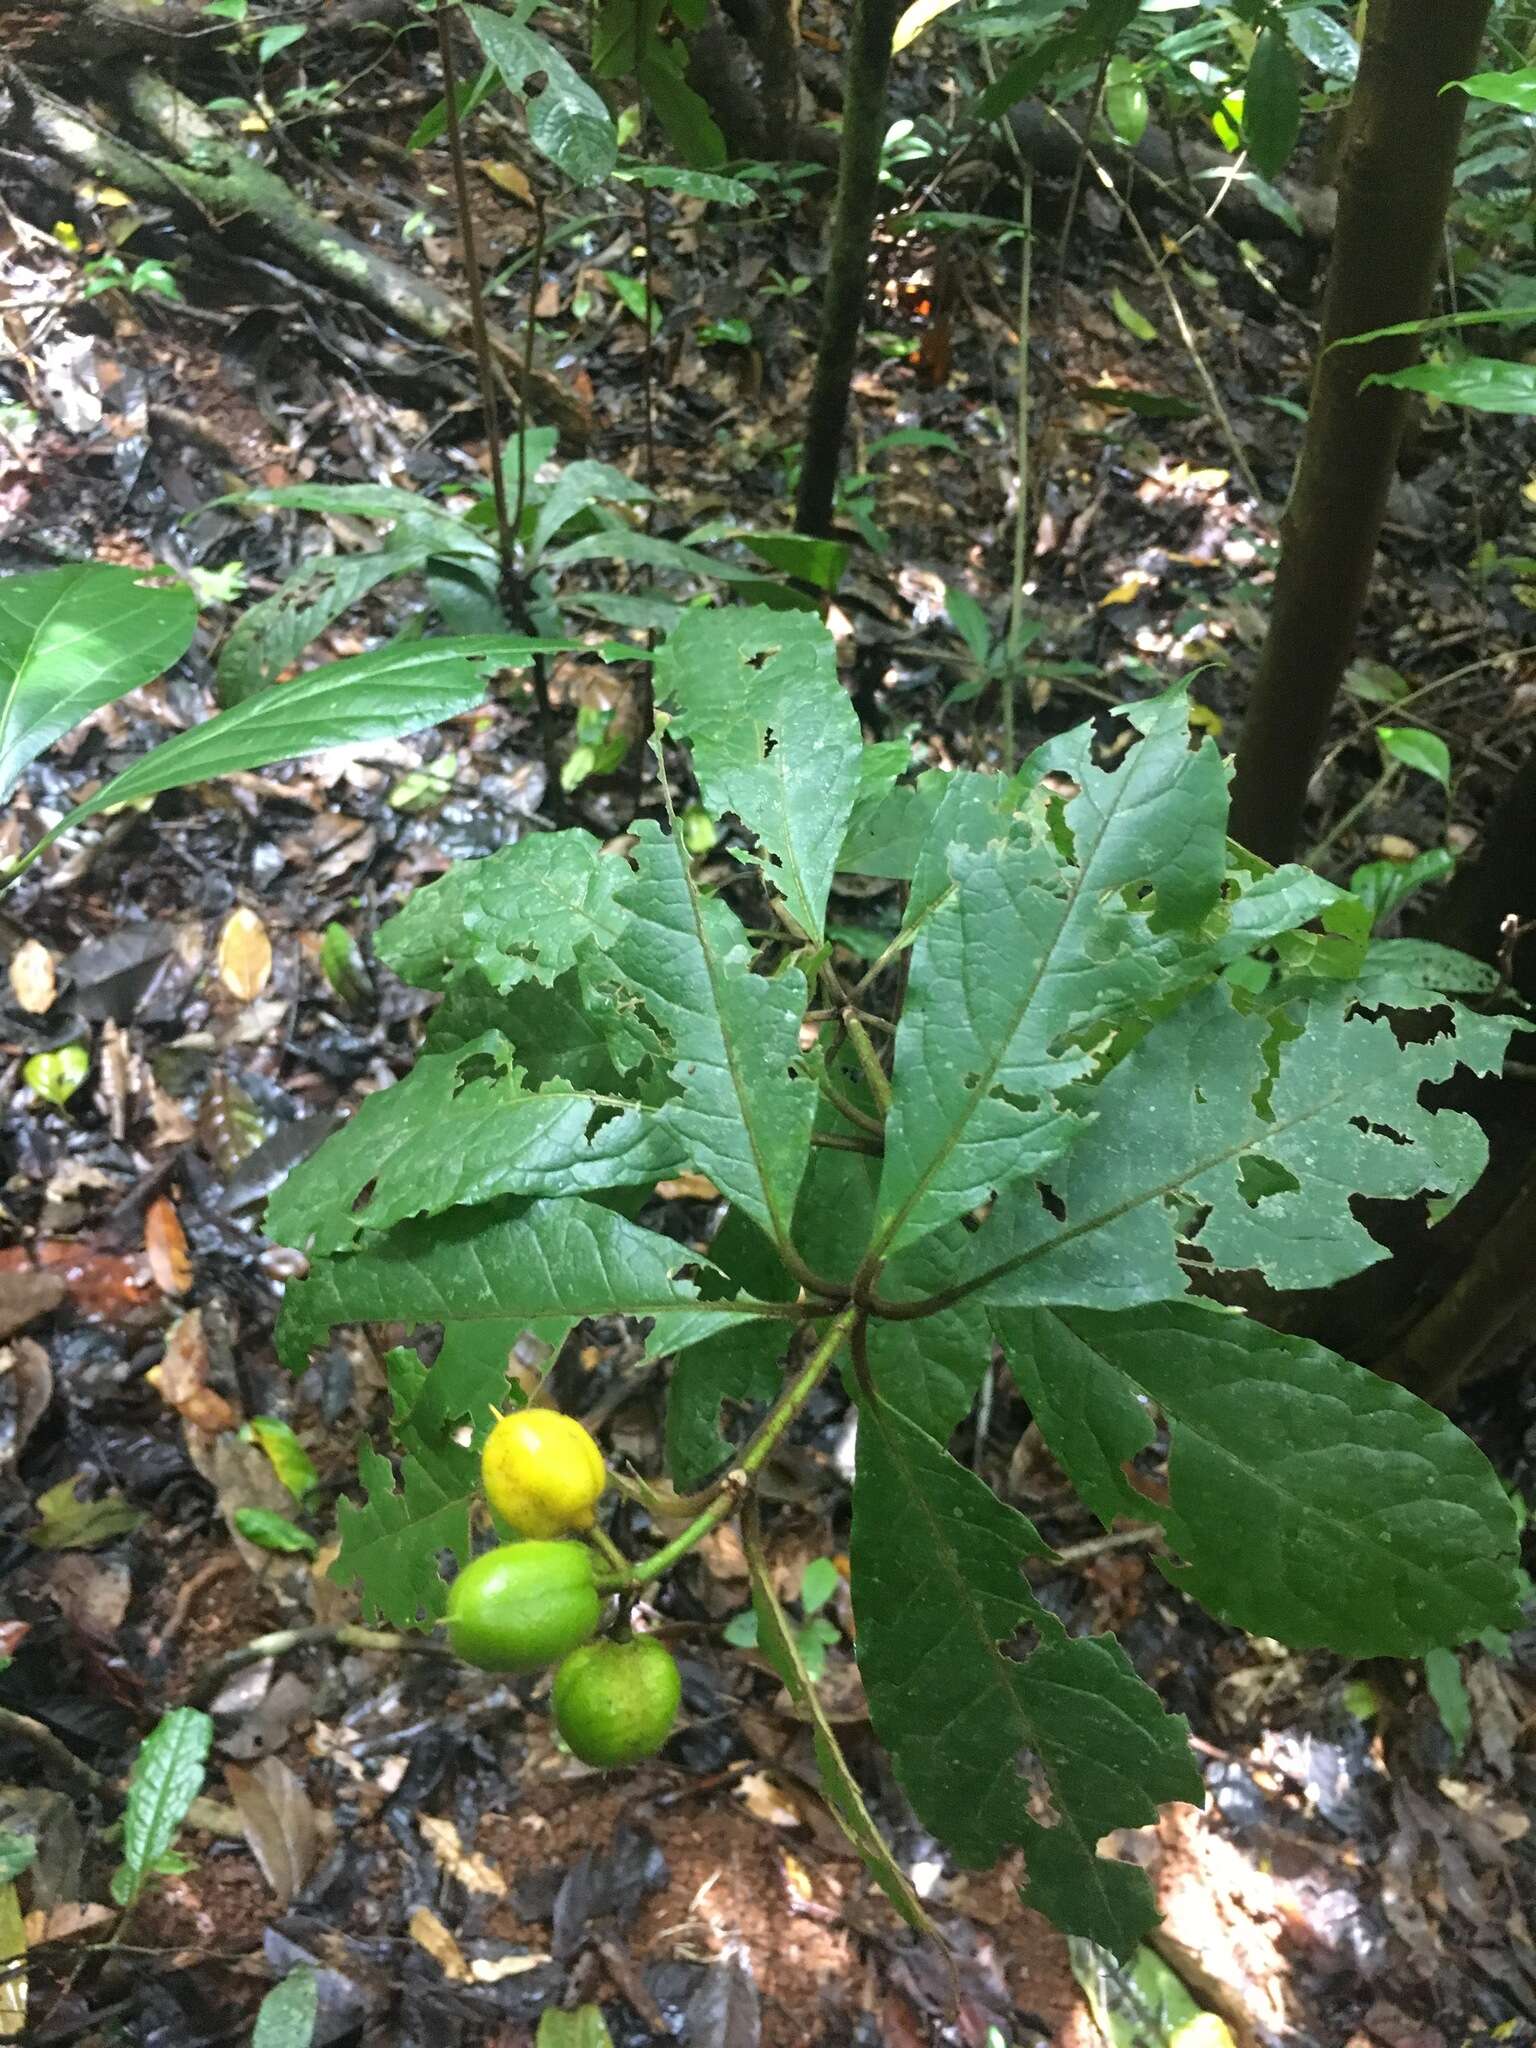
[{"x1": 449, "y1": 1542, "x2": 602, "y2": 1671}]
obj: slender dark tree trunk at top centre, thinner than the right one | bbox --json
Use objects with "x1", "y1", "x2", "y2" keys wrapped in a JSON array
[{"x1": 795, "y1": 0, "x2": 901, "y2": 535}]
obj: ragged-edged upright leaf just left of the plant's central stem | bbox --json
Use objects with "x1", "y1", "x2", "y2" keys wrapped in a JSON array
[{"x1": 610, "y1": 819, "x2": 817, "y2": 1245}]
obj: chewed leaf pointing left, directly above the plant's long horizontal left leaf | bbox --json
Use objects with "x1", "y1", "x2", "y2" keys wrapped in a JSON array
[{"x1": 266, "y1": 1030, "x2": 684, "y2": 1255}]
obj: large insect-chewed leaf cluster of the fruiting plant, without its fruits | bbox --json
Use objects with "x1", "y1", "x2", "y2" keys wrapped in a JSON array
[{"x1": 268, "y1": 608, "x2": 1518, "y2": 1952}]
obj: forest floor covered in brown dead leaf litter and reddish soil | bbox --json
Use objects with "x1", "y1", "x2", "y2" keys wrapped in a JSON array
[{"x1": 0, "y1": 8, "x2": 1536, "y2": 2048}]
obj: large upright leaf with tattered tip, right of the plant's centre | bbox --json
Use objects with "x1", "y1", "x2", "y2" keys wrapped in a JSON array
[{"x1": 874, "y1": 692, "x2": 1227, "y2": 1253}]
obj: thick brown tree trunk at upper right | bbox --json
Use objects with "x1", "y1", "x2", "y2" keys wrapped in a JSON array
[{"x1": 1231, "y1": 0, "x2": 1489, "y2": 860}]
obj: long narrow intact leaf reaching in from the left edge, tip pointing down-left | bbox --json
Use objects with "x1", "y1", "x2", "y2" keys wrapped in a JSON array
[{"x1": 8, "y1": 633, "x2": 569, "y2": 881}]
